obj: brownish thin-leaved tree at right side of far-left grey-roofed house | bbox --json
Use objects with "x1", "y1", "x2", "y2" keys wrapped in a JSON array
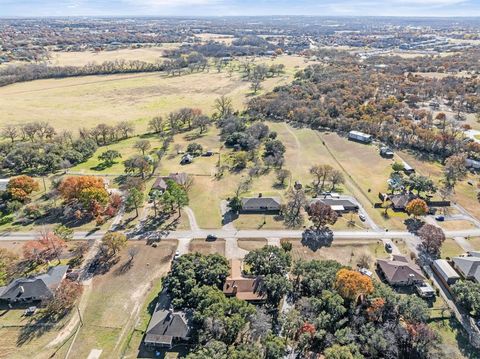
[{"x1": 44, "y1": 279, "x2": 83, "y2": 320}]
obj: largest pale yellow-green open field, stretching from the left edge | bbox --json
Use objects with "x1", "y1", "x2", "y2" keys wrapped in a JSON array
[{"x1": 0, "y1": 50, "x2": 307, "y2": 133}]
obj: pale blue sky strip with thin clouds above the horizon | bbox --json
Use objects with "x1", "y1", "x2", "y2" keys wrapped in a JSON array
[{"x1": 0, "y1": 0, "x2": 480, "y2": 17}]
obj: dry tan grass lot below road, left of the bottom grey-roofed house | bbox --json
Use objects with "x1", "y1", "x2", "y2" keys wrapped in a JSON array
[{"x1": 68, "y1": 241, "x2": 176, "y2": 358}]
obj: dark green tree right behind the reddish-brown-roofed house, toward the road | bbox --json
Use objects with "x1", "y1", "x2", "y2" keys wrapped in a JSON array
[{"x1": 245, "y1": 246, "x2": 291, "y2": 275}]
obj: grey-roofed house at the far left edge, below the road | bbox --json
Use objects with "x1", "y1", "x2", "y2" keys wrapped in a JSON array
[{"x1": 0, "y1": 265, "x2": 68, "y2": 303}]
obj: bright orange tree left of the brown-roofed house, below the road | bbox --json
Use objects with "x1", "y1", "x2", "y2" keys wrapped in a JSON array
[{"x1": 335, "y1": 268, "x2": 373, "y2": 300}]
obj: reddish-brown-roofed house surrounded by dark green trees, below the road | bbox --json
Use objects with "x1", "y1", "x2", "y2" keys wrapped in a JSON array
[{"x1": 223, "y1": 259, "x2": 267, "y2": 303}]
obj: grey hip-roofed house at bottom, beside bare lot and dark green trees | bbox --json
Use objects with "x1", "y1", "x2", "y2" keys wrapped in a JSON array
[{"x1": 144, "y1": 303, "x2": 191, "y2": 348}]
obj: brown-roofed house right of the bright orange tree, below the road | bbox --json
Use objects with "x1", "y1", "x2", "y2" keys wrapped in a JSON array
[{"x1": 377, "y1": 255, "x2": 425, "y2": 286}]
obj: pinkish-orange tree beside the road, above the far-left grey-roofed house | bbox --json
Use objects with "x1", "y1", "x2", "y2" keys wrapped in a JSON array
[{"x1": 23, "y1": 231, "x2": 67, "y2": 264}]
